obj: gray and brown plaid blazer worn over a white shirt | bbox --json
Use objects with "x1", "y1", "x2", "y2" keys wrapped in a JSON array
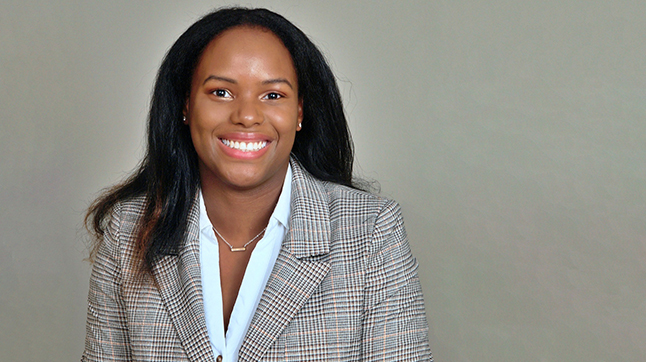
[{"x1": 82, "y1": 160, "x2": 432, "y2": 362}]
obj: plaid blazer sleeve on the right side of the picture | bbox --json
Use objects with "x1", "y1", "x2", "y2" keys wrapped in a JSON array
[{"x1": 362, "y1": 201, "x2": 433, "y2": 361}]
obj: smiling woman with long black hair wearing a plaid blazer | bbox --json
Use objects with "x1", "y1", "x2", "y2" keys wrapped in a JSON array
[{"x1": 83, "y1": 8, "x2": 431, "y2": 361}]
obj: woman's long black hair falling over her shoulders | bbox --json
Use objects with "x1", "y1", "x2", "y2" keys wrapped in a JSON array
[{"x1": 86, "y1": 7, "x2": 357, "y2": 271}]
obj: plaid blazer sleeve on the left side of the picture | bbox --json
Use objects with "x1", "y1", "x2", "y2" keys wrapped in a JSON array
[{"x1": 81, "y1": 205, "x2": 132, "y2": 362}]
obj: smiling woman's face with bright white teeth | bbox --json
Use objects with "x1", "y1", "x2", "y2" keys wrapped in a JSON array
[{"x1": 186, "y1": 27, "x2": 303, "y2": 190}]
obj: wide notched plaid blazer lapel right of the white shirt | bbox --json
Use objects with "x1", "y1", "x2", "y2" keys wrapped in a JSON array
[{"x1": 238, "y1": 160, "x2": 330, "y2": 361}]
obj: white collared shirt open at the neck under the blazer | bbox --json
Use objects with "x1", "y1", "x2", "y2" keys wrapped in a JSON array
[{"x1": 199, "y1": 165, "x2": 292, "y2": 362}]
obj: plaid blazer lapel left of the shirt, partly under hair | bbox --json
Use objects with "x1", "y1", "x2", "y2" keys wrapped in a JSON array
[{"x1": 153, "y1": 199, "x2": 214, "y2": 362}]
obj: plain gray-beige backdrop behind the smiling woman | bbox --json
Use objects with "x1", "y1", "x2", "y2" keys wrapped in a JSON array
[{"x1": 0, "y1": 0, "x2": 646, "y2": 362}]
